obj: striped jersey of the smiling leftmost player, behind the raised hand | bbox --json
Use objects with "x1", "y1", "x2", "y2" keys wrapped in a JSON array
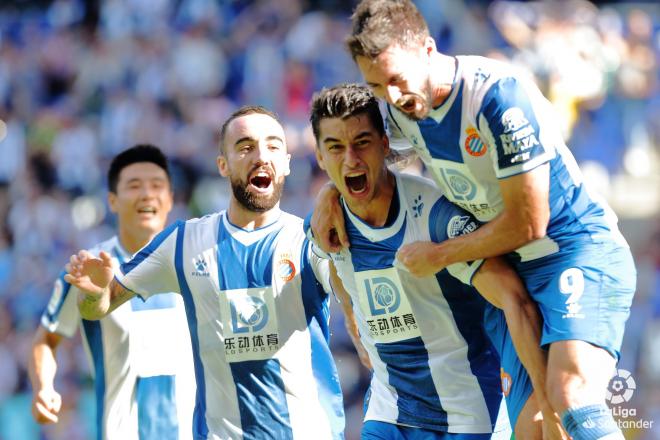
[{"x1": 41, "y1": 237, "x2": 195, "y2": 440}]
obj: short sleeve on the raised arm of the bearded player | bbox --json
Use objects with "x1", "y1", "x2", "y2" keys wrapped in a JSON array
[{"x1": 115, "y1": 222, "x2": 184, "y2": 299}]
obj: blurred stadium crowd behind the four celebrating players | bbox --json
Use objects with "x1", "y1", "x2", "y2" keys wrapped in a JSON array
[{"x1": 0, "y1": 0, "x2": 660, "y2": 440}]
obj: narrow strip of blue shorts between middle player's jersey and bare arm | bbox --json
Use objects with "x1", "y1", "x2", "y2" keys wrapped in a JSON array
[{"x1": 484, "y1": 304, "x2": 534, "y2": 429}]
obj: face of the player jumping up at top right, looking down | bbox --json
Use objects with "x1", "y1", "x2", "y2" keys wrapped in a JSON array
[{"x1": 355, "y1": 38, "x2": 435, "y2": 120}]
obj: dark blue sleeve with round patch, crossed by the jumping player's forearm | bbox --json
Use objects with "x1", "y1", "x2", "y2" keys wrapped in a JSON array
[{"x1": 429, "y1": 197, "x2": 483, "y2": 285}]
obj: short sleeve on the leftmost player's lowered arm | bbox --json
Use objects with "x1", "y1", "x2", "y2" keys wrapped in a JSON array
[{"x1": 41, "y1": 271, "x2": 80, "y2": 338}]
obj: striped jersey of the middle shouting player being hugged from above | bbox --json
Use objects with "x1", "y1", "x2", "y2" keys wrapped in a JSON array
[{"x1": 314, "y1": 173, "x2": 510, "y2": 438}]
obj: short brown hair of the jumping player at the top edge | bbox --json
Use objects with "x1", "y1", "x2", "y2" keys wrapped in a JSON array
[{"x1": 346, "y1": 0, "x2": 430, "y2": 59}]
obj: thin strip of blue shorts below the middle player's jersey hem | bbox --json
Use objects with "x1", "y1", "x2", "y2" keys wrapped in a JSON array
[{"x1": 360, "y1": 420, "x2": 511, "y2": 440}]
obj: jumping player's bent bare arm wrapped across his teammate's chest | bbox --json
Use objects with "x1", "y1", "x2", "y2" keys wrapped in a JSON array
[{"x1": 397, "y1": 163, "x2": 550, "y2": 276}]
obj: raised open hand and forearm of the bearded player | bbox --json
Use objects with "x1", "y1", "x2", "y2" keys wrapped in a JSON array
[{"x1": 64, "y1": 251, "x2": 135, "y2": 320}]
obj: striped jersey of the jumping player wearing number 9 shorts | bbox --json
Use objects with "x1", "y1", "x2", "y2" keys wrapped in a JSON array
[{"x1": 388, "y1": 56, "x2": 625, "y2": 261}]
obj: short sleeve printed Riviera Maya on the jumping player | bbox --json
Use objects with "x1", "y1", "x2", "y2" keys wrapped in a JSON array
[{"x1": 478, "y1": 78, "x2": 556, "y2": 178}]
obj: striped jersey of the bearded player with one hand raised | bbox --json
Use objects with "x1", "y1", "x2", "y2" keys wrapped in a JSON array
[{"x1": 117, "y1": 211, "x2": 344, "y2": 440}]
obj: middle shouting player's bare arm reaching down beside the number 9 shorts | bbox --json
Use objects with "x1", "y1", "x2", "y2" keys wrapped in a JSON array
[{"x1": 472, "y1": 258, "x2": 568, "y2": 440}]
